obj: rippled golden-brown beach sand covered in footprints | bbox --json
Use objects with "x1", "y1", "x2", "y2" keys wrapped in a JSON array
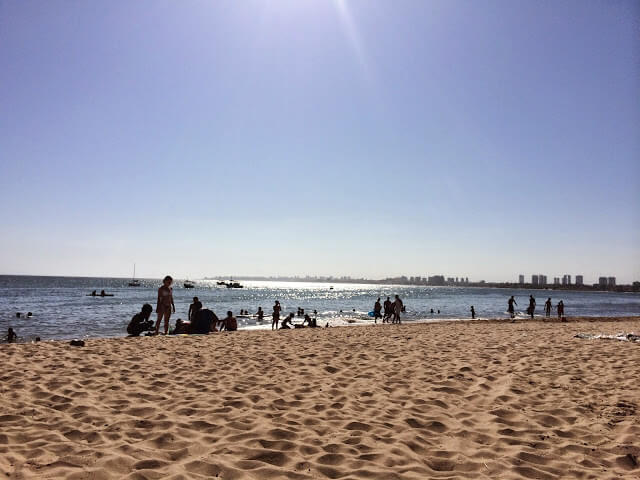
[{"x1": 0, "y1": 318, "x2": 640, "y2": 480}]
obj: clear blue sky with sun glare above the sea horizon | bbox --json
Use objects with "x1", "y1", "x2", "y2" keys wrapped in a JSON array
[{"x1": 0, "y1": 0, "x2": 640, "y2": 283}]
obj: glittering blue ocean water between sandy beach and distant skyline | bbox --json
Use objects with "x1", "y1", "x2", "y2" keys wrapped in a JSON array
[{"x1": 0, "y1": 275, "x2": 640, "y2": 341}]
